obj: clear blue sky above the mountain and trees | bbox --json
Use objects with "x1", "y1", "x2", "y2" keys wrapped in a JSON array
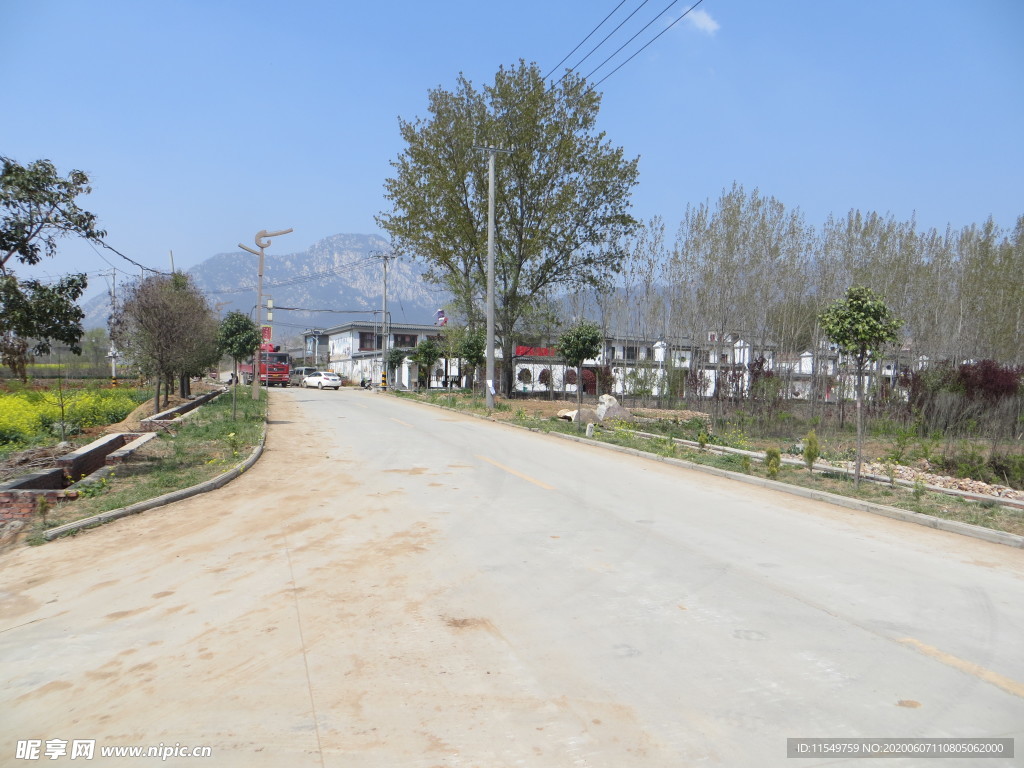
[{"x1": 0, "y1": 0, "x2": 1024, "y2": 299}]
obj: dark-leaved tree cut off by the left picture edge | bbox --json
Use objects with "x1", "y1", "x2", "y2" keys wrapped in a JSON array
[{"x1": 0, "y1": 158, "x2": 106, "y2": 381}]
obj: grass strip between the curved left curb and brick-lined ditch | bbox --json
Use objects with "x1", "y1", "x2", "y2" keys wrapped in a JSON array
[{"x1": 29, "y1": 387, "x2": 266, "y2": 544}]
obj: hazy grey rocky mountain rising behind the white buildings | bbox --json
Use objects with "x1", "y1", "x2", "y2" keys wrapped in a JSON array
[{"x1": 82, "y1": 234, "x2": 447, "y2": 340}]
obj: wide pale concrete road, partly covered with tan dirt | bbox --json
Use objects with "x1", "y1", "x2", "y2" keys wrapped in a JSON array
[{"x1": 0, "y1": 389, "x2": 1024, "y2": 768}]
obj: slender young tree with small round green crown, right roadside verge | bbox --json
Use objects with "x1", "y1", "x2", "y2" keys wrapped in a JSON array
[{"x1": 818, "y1": 286, "x2": 902, "y2": 486}]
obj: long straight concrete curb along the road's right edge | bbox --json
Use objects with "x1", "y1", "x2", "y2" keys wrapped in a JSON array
[{"x1": 393, "y1": 398, "x2": 1024, "y2": 549}]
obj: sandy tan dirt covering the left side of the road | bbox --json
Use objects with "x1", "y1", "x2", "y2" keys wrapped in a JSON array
[{"x1": 0, "y1": 393, "x2": 663, "y2": 768}]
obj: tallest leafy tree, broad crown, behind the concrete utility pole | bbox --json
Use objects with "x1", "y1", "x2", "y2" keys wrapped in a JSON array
[{"x1": 377, "y1": 61, "x2": 638, "y2": 391}]
